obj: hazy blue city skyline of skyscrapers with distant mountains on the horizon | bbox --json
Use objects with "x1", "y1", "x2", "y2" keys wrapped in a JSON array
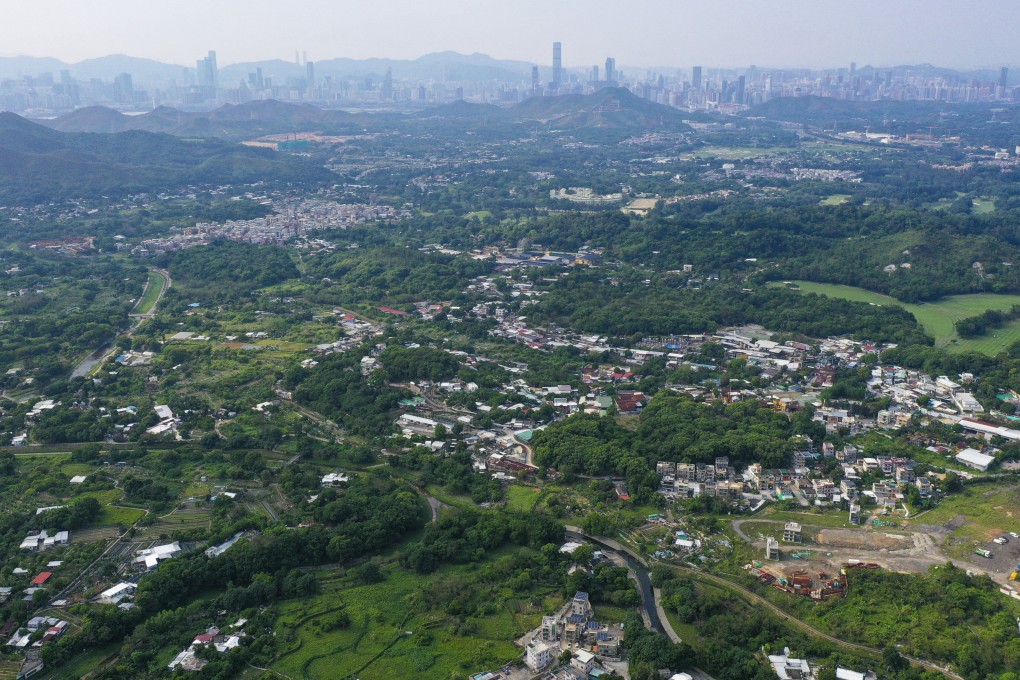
[{"x1": 0, "y1": 43, "x2": 1020, "y2": 116}]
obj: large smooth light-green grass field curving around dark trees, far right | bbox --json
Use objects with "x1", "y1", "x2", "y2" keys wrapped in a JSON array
[{"x1": 775, "y1": 281, "x2": 1020, "y2": 355}]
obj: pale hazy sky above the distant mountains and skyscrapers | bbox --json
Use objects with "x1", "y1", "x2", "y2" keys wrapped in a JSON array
[{"x1": 0, "y1": 0, "x2": 1020, "y2": 66}]
